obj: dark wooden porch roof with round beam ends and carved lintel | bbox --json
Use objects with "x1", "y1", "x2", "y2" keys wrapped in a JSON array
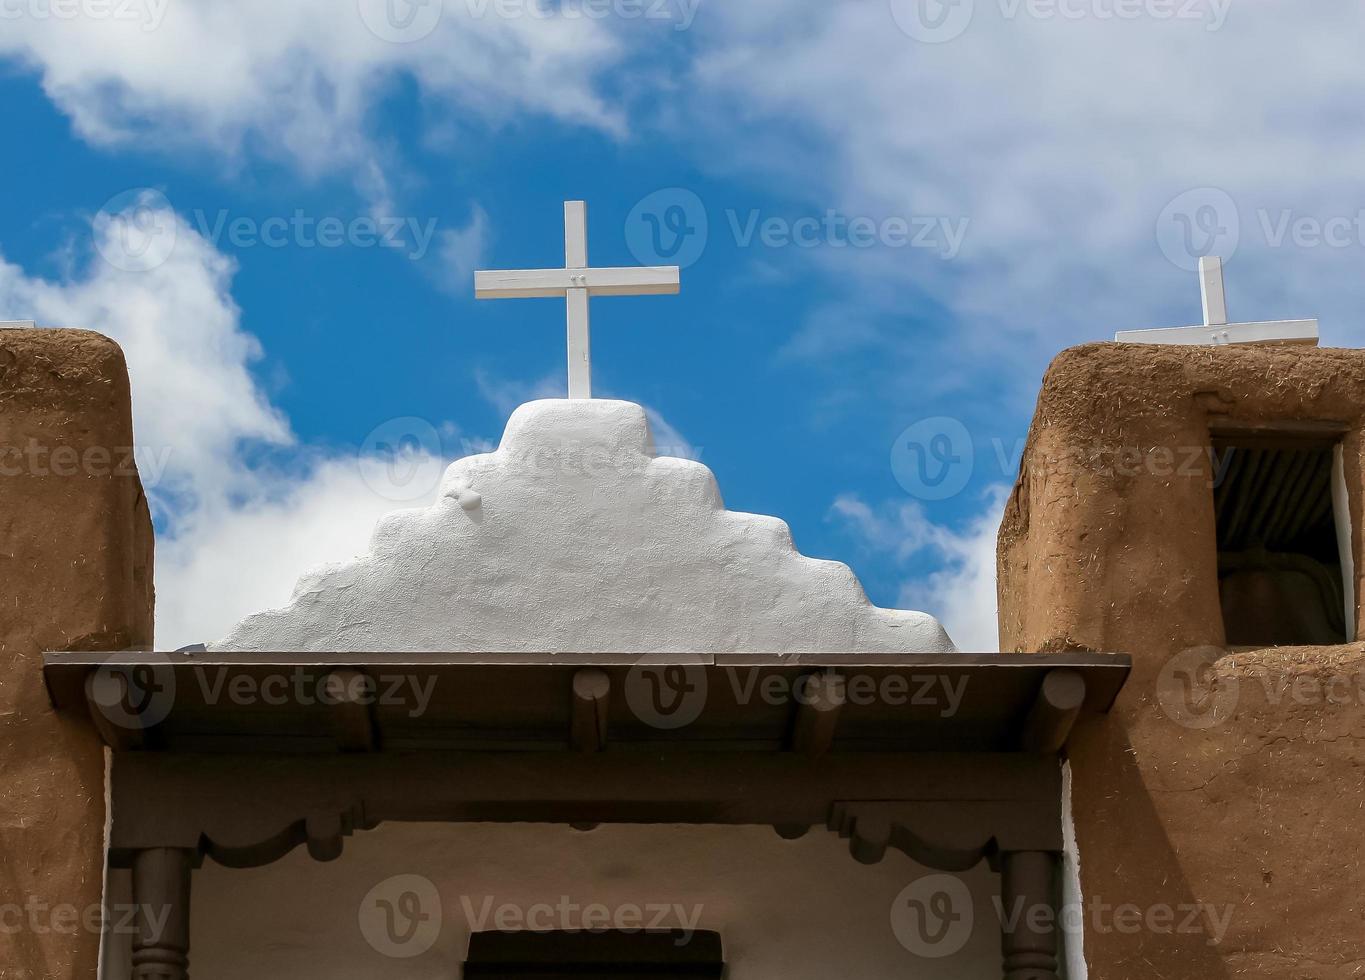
[{"x1": 44, "y1": 651, "x2": 1132, "y2": 976}]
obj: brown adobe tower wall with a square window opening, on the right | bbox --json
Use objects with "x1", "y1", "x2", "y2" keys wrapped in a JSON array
[{"x1": 998, "y1": 344, "x2": 1365, "y2": 980}]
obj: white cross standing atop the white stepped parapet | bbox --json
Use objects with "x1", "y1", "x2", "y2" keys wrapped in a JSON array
[{"x1": 474, "y1": 201, "x2": 681, "y2": 399}]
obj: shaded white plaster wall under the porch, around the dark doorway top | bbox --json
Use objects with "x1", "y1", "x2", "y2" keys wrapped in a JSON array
[{"x1": 170, "y1": 824, "x2": 1001, "y2": 980}]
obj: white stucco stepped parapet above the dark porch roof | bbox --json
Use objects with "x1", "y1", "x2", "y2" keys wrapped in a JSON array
[{"x1": 209, "y1": 400, "x2": 954, "y2": 652}]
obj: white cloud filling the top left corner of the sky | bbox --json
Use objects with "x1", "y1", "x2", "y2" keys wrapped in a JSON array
[{"x1": 0, "y1": 0, "x2": 625, "y2": 200}]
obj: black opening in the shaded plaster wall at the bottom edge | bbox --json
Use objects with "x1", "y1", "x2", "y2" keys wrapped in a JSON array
[{"x1": 464, "y1": 929, "x2": 725, "y2": 980}]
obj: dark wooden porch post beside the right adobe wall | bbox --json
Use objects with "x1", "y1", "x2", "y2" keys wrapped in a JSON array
[{"x1": 1001, "y1": 850, "x2": 1058, "y2": 980}]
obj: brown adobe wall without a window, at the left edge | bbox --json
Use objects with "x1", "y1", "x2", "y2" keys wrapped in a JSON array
[{"x1": 0, "y1": 329, "x2": 152, "y2": 980}]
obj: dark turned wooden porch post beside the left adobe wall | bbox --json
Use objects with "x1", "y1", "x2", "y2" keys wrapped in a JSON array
[{"x1": 132, "y1": 848, "x2": 194, "y2": 980}]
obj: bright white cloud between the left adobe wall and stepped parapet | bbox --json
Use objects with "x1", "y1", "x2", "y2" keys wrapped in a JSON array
[{"x1": 0, "y1": 203, "x2": 464, "y2": 648}]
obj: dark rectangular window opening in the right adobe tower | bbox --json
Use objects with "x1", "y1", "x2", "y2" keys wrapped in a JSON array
[{"x1": 1212, "y1": 433, "x2": 1354, "y2": 647}]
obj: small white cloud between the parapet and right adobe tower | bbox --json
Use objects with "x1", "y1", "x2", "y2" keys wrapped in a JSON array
[{"x1": 830, "y1": 486, "x2": 1009, "y2": 652}]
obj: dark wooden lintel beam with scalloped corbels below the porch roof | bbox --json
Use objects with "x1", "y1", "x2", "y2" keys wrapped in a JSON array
[{"x1": 111, "y1": 748, "x2": 1062, "y2": 867}]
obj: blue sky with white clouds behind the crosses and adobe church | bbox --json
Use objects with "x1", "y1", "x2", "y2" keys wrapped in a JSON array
[{"x1": 0, "y1": 0, "x2": 1365, "y2": 647}]
